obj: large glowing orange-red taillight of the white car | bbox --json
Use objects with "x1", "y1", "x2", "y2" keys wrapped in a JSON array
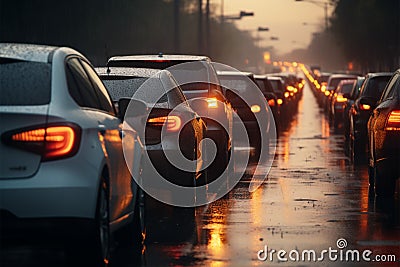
[{"x1": 4, "y1": 124, "x2": 81, "y2": 161}]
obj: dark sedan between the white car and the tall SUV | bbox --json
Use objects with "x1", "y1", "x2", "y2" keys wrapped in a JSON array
[{"x1": 96, "y1": 67, "x2": 205, "y2": 204}]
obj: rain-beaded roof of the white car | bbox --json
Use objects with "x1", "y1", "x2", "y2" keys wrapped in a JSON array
[{"x1": 0, "y1": 43, "x2": 59, "y2": 63}]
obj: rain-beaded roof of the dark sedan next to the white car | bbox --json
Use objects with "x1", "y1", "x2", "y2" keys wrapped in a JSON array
[{"x1": 95, "y1": 67, "x2": 162, "y2": 78}]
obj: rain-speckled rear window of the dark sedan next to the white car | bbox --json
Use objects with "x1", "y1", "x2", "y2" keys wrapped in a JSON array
[{"x1": 100, "y1": 76, "x2": 168, "y2": 104}]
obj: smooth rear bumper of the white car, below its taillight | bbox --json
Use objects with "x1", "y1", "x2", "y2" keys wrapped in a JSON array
[{"x1": 0, "y1": 159, "x2": 99, "y2": 219}]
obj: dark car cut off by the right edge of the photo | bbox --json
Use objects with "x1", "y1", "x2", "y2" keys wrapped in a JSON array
[{"x1": 368, "y1": 69, "x2": 400, "y2": 197}]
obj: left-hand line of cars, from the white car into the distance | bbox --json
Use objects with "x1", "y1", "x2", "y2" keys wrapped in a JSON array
[{"x1": 0, "y1": 43, "x2": 304, "y2": 266}]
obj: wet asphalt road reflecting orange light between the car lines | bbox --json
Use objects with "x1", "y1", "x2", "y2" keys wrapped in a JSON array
[{"x1": 0, "y1": 78, "x2": 400, "y2": 267}]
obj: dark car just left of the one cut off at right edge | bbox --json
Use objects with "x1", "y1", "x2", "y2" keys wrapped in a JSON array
[{"x1": 349, "y1": 72, "x2": 392, "y2": 162}]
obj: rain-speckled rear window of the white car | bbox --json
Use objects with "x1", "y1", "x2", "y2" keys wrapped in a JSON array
[{"x1": 0, "y1": 58, "x2": 51, "y2": 106}]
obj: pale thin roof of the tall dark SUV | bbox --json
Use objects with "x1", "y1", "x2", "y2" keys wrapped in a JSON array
[{"x1": 108, "y1": 54, "x2": 210, "y2": 61}]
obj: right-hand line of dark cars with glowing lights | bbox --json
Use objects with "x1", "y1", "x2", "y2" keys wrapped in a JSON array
[{"x1": 304, "y1": 65, "x2": 400, "y2": 197}]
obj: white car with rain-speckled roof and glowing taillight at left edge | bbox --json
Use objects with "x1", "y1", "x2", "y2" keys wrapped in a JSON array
[{"x1": 0, "y1": 43, "x2": 145, "y2": 266}]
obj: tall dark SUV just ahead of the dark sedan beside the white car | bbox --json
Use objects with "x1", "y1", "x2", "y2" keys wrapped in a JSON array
[{"x1": 107, "y1": 54, "x2": 233, "y2": 180}]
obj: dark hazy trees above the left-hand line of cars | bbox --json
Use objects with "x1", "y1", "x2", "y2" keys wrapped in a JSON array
[{"x1": 0, "y1": 0, "x2": 260, "y2": 68}]
